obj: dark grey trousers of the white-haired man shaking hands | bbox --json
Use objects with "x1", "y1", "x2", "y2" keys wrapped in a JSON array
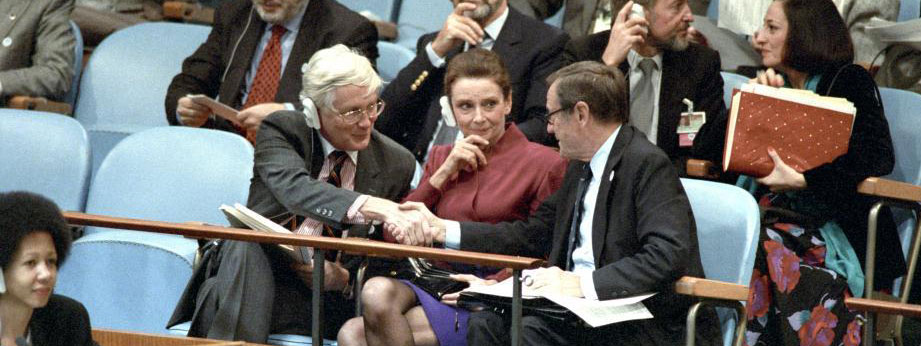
[{"x1": 189, "y1": 241, "x2": 355, "y2": 343}]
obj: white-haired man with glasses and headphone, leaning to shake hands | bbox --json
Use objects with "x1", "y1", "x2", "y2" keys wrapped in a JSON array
[{"x1": 170, "y1": 45, "x2": 422, "y2": 343}]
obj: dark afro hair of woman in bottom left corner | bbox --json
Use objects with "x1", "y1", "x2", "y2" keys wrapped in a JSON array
[{"x1": 0, "y1": 191, "x2": 71, "y2": 270}]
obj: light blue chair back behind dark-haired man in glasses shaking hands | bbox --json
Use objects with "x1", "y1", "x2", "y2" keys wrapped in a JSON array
[{"x1": 681, "y1": 179, "x2": 761, "y2": 345}]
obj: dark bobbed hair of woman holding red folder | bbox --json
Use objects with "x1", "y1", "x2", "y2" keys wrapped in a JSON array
[{"x1": 777, "y1": 0, "x2": 854, "y2": 74}]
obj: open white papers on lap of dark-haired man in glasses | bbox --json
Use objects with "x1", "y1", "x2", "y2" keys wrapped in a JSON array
[{"x1": 461, "y1": 279, "x2": 655, "y2": 328}]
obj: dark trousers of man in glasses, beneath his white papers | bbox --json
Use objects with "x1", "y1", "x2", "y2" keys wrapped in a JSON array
[{"x1": 467, "y1": 310, "x2": 721, "y2": 346}]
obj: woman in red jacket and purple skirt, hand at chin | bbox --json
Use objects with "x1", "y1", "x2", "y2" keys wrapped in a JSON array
[{"x1": 339, "y1": 49, "x2": 566, "y2": 346}]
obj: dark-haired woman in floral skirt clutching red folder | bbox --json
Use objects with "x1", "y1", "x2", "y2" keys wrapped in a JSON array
[{"x1": 745, "y1": 0, "x2": 905, "y2": 345}]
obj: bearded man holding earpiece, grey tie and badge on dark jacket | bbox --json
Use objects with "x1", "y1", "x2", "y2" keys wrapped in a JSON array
[{"x1": 563, "y1": 0, "x2": 726, "y2": 175}]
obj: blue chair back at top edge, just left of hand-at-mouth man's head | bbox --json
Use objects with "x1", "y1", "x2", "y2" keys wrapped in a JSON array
[{"x1": 396, "y1": 0, "x2": 454, "y2": 51}]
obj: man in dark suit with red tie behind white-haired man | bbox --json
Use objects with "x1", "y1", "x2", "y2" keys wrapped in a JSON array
[{"x1": 166, "y1": 0, "x2": 378, "y2": 142}]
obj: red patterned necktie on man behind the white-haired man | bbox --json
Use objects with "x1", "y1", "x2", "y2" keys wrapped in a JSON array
[{"x1": 237, "y1": 25, "x2": 287, "y2": 143}]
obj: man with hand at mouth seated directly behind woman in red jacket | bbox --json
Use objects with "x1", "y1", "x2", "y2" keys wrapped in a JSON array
[{"x1": 377, "y1": 0, "x2": 568, "y2": 161}]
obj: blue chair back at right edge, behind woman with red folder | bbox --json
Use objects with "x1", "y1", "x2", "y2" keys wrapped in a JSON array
[{"x1": 879, "y1": 88, "x2": 921, "y2": 266}]
